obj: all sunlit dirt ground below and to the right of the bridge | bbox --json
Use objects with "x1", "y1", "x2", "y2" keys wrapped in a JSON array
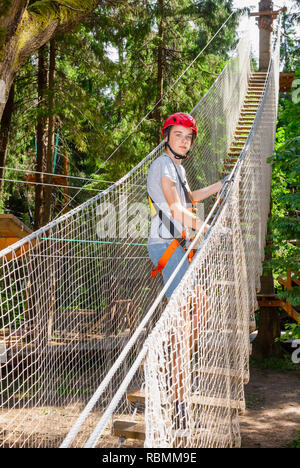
[{"x1": 0, "y1": 367, "x2": 300, "y2": 448}]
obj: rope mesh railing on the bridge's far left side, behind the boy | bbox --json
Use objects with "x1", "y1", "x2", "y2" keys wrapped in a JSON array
[{"x1": 0, "y1": 31, "x2": 276, "y2": 447}]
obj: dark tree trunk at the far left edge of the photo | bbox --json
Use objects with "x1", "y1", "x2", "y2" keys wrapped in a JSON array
[{"x1": 0, "y1": 84, "x2": 15, "y2": 206}]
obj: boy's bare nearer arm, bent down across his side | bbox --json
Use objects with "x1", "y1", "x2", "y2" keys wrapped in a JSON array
[{"x1": 161, "y1": 177, "x2": 209, "y2": 233}]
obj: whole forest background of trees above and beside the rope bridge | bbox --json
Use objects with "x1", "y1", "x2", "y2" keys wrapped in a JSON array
[{"x1": 0, "y1": 0, "x2": 300, "y2": 348}]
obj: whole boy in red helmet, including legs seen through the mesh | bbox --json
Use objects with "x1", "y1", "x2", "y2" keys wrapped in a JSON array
[{"x1": 147, "y1": 112, "x2": 225, "y2": 429}]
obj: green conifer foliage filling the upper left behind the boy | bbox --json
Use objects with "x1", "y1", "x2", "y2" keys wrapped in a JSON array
[{"x1": 3, "y1": 0, "x2": 238, "y2": 222}]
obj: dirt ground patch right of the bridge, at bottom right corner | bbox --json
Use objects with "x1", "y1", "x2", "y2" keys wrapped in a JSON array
[{"x1": 240, "y1": 368, "x2": 300, "y2": 448}]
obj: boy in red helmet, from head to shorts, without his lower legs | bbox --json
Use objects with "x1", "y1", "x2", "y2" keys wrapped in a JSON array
[{"x1": 147, "y1": 112, "x2": 223, "y2": 299}]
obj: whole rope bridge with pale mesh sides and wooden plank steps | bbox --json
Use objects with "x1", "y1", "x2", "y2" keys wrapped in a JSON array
[{"x1": 0, "y1": 27, "x2": 279, "y2": 447}]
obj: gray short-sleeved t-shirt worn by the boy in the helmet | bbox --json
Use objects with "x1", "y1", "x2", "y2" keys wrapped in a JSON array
[{"x1": 147, "y1": 153, "x2": 190, "y2": 244}]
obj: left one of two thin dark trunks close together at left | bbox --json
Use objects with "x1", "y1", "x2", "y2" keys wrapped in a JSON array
[{"x1": 34, "y1": 46, "x2": 47, "y2": 229}]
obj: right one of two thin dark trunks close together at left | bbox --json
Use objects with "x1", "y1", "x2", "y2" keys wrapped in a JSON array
[{"x1": 43, "y1": 39, "x2": 55, "y2": 225}]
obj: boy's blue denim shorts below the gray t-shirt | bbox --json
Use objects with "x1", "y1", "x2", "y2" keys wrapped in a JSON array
[{"x1": 148, "y1": 242, "x2": 189, "y2": 298}]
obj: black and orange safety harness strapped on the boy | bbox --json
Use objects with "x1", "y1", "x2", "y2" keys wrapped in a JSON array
[{"x1": 148, "y1": 158, "x2": 195, "y2": 278}]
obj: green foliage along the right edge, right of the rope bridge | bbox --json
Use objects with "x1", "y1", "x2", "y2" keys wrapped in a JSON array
[{"x1": 269, "y1": 67, "x2": 300, "y2": 338}]
